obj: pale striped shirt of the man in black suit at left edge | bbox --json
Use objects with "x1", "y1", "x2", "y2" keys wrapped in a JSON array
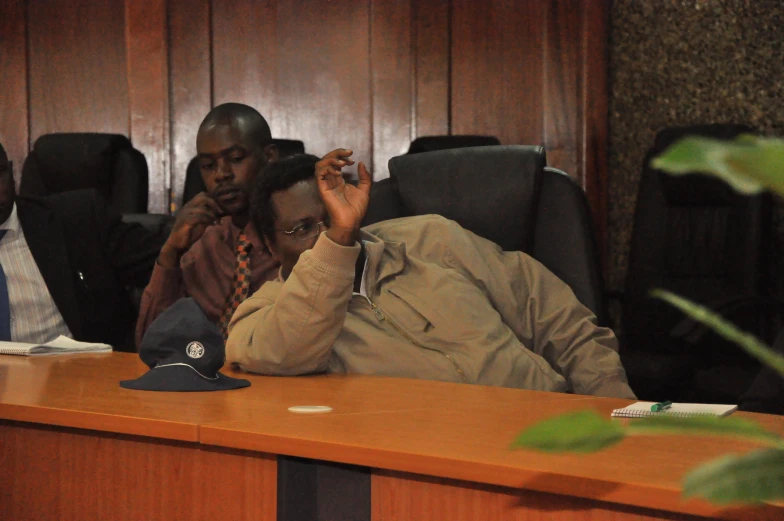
[{"x1": 0, "y1": 203, "x2": 72, "y2": 344}]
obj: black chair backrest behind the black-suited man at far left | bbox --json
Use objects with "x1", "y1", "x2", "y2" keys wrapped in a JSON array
[{"x1": 19, "y1": 133, "x2": 148, "y2": 213}]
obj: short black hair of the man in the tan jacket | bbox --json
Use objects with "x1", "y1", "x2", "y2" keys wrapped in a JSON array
[{"x1": 250, "y1": 154, "x2": 320, "y2": 244}]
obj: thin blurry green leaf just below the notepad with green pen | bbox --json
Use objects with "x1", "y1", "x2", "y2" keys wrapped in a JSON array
[{"x1": 626, "y1": 415, "x2": 782, "y2": 445}]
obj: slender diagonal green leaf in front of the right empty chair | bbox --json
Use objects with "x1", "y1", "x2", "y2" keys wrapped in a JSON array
[{"x1": 651, "y1": 289, "x2": 784, "y2": 377}]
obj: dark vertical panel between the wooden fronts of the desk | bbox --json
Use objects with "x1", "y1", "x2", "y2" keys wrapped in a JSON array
[{"x1": 278, "y1": 456, "x2": 370, "y2": 521}]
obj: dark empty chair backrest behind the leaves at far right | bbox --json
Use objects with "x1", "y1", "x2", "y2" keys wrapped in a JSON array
[{"x1": 623, "y1": 125, "x2": 771, "y2": 355}]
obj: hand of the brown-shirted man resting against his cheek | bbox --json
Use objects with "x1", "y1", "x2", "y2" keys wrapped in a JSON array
[{"x1": 158, "y1": 192, "x2": 223, "y2": 269}]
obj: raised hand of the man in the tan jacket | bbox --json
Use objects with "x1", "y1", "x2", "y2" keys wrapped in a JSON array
[{"x1": 316, "y1": 148, "x2": 373, "y2": 246}]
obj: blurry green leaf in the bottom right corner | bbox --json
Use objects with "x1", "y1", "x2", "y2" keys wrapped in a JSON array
[{"x1": 683, "y1": 449, "x2": 784, "y2": 505}]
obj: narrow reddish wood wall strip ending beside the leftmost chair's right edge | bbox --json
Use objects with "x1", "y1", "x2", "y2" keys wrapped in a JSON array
[{"x1": 125, "y1": 0, "x2": 171, "y2": 213}]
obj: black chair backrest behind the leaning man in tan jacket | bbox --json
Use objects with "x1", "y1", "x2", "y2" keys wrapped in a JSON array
[{"x1": 364, "y1": 145, "x2": 606, "y2": 324}]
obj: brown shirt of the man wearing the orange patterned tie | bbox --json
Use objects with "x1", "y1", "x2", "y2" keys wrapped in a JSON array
[{"x1": 136, "y1": 217, "x2": 279, "y2": 346}]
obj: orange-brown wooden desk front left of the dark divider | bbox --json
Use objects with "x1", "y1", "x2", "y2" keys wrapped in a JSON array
[{"x1": 0, "y1": 422, "x2": 277, "y2": 521}]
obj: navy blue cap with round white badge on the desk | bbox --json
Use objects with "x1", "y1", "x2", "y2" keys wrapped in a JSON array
[{"x1": 120, "y1": 298, "x2": 250, "y2": 391}]
